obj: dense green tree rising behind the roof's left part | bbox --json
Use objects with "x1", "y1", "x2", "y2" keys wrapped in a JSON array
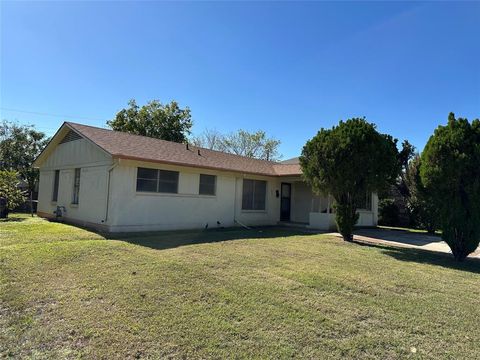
[{"x1": 107, "y1": 100, "x2": 193, "y2": 143}]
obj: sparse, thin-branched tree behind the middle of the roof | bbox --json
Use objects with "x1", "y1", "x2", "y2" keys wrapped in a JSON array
[{"x1": 191, "y1": 130, "x2": 281, "y2": 161}]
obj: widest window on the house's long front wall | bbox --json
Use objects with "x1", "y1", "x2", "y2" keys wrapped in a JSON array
[{"x1": 137, "y1": 168, "x2": 178, "y2": 194}]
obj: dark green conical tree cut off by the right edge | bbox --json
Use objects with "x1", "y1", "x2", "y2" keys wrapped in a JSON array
[{"x1": 420, "y1": 113, "x2": 480, "y2": 261}]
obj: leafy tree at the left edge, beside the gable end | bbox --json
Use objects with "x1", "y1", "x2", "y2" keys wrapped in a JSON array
[{"x1": 0, "y1": 121, "x2": 49, "y2": 191}]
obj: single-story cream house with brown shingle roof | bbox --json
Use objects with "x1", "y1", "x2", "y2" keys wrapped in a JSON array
[{"x1": 34, "y1": 122, "x2": 378, "y2": 232}]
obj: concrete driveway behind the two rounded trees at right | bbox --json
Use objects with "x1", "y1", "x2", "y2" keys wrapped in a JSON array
[{"x1": 331, "y1": 229, "x2": 480, "y2": 259}]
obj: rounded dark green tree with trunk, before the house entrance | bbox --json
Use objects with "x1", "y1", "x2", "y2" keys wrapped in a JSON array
[{"x1": 300, "y1": 118, "x2": 400, "y2": 241}]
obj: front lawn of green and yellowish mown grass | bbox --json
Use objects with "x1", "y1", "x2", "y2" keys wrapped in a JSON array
[{"x1": 0, "y1": 217, "x2": 480, "y2": 359}]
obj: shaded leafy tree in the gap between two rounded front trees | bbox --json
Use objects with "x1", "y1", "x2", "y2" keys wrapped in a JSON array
[{"x1": 405, "y1": 155, "x2": 438, "y2": 234}]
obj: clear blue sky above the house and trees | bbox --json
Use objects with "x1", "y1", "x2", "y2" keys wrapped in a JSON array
[{"x1": 0, "y1": 2, "x2": 480, "y2": 158}]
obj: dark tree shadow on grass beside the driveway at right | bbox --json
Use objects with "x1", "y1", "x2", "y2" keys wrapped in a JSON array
[{"x1": 354, "y1": 241, "x2": 480, "y2": 274}]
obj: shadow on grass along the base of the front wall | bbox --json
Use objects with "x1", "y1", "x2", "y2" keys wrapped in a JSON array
[{"x1": 102, "y1": 227, "x2": 311, "y2": 250}]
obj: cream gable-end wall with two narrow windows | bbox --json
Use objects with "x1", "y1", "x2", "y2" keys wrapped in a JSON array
[{"x1": 37, "y1": 139, "x2": 112, "y2": 225}]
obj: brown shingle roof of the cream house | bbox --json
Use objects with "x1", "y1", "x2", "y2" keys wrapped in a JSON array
[{"x1": 66, "y1": 122, "x2": 301, "y2": 176}]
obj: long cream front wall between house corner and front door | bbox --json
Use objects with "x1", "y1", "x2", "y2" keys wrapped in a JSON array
[{"x1": 108, "y1": 160, "x2": 280, "y2": 231}]
